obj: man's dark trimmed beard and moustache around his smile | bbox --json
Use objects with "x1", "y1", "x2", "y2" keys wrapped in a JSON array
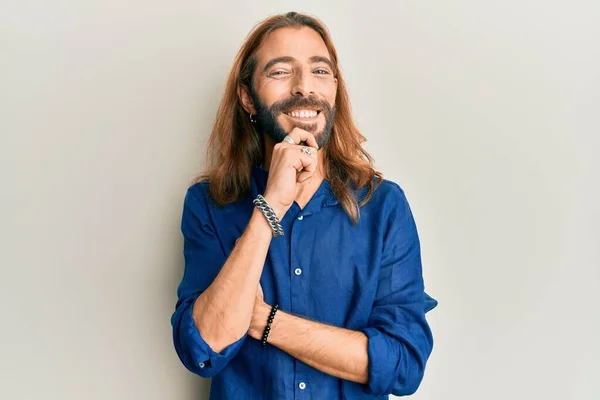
[{"x1": 250, "y1": 88, "x2": 335, "y2": 149}]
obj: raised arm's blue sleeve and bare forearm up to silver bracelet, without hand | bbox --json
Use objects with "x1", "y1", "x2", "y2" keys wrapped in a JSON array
[{"x1": 171, "y1": 185, "x2": 272, "y2": 377}]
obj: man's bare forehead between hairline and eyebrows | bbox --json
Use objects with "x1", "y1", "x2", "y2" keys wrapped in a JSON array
[{"x1": 256, "y1": 27, "x2": 330, "y2": 67}]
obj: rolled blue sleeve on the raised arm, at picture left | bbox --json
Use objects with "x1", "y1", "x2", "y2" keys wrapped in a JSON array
[{"x1": 171, "y1": 187, "x2": 248, "y2": 378}]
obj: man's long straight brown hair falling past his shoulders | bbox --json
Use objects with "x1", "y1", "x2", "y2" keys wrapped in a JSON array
[{"x1": 193, "y1": 12, "x2": 383, "y2": 224}]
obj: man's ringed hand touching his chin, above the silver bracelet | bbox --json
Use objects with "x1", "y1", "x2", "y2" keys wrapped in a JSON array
[{"x1": 264, "y1": 128, "x2": 319, "y2": 219}]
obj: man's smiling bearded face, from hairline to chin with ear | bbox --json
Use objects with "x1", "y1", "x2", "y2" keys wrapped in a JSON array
[{"x1": 241, "y1": 27, "x2": 337, "y2": 148}]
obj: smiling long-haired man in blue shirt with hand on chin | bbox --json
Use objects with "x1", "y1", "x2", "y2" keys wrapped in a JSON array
[{"x1": 171, "y1": 12, "x2": 437, "y2": 400}]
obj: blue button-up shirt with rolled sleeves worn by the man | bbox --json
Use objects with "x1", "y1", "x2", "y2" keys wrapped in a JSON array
[{"x1": 171, "y1": 167, "x2": 437, "y2": 400}]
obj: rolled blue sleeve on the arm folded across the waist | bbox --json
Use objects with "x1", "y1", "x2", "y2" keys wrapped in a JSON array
[{"x1": 362, "y1": 185, "x2": 437, "y2": 396}]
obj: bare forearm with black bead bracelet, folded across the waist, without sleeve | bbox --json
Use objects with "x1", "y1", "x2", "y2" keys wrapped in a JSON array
[{"x1": 248, "y1": 298, "x2": 369, "y2": 383}]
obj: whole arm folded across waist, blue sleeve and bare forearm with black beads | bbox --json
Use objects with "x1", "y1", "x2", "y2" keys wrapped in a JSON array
[{"x1": 248, "y1": 188, "x2": 437, "y2": 395}]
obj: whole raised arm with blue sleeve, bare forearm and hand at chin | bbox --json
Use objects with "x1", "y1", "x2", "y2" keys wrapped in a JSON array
[{"x1": 172, "y1": 128, "x2": 318, "y2": 376}]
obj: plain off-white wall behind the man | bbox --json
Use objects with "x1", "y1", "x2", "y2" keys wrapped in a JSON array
[{"x1": 0, "y1": 0, "x2": 600, "y2": 400}]
